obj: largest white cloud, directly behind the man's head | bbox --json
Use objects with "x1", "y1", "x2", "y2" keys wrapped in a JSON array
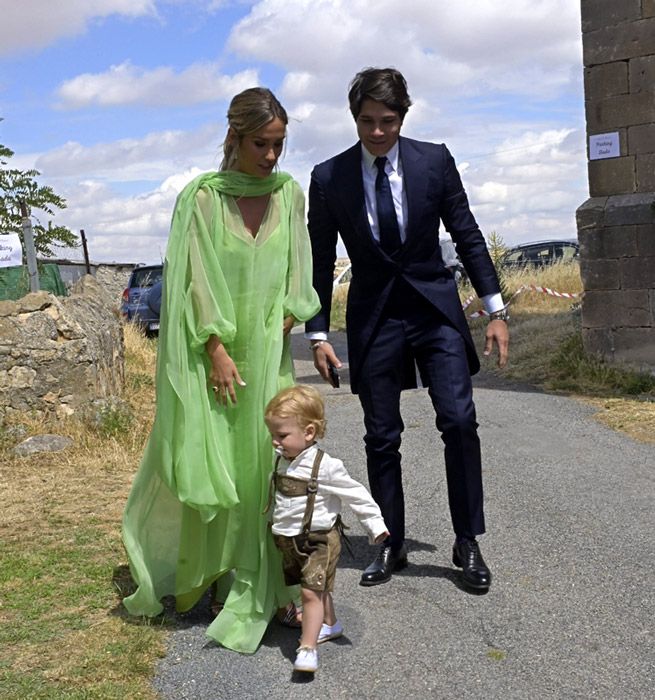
[{"x1": 228, "y1": 0, "x2": 582, "y2": 186}]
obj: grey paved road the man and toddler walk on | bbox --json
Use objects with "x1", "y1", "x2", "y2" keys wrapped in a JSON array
[{"x1": 155, "y1": 330, "x2": 655, "y2": 700}]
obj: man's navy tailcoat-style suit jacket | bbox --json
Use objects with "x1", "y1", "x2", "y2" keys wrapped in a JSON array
[{"x1": 306, "y1": 136, "x2": 500, "y2": 393}]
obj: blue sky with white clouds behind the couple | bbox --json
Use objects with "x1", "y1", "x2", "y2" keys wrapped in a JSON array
[{"x1": 0, "y1": 0, "x2": 588, "y2": 263}]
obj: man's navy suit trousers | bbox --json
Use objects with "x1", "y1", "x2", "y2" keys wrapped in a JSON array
[{"x1": 359, "y1": 280, "x2": 485, "y2": 551}]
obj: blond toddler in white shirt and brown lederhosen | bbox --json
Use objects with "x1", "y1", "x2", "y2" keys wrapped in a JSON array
[{"x1": 265, "y1": 384, "x2": 389, "y2": 673}]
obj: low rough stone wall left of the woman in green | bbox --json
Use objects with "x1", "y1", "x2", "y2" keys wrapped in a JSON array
[{"x1": 0, "y1": 275, "x2": 125, "y2": 414}]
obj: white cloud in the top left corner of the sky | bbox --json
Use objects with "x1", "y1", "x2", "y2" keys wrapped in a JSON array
[{"x1": 0, "y1": 0, "x2": 155, "y2": 55}]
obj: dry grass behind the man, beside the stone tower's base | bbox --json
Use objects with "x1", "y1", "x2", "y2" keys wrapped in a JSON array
[{"x1": 332, "y1": 263, "x2": 655, "y2": 442}]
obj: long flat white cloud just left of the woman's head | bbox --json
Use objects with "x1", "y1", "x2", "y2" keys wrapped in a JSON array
[{"x1": 57, "y1": 61, "x2": 258, "y2": 109}]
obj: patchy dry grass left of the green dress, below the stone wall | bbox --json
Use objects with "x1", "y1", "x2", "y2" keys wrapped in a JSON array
[{"x1": 0, "y1": 326, "x2": 165, "y2": 699}]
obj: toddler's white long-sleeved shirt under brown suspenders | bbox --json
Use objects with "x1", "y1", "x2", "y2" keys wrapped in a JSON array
[{"x1": 271, "y1": 444, "x2": 387, "y2": 544}]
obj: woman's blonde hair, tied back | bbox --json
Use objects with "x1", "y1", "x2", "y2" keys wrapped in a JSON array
[{"x1": 221, "y1": 88, "x2": 289, "y2": 170}]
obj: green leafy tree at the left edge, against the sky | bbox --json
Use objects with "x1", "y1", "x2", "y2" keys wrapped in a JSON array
[{"x1": 0, "y1": 133, "x2": 80, "y2": 257}]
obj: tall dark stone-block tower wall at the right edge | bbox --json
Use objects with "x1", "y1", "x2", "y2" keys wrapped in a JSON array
[{"x1": 577, "y1": 0, "x2": 655, "y2": 370}]
